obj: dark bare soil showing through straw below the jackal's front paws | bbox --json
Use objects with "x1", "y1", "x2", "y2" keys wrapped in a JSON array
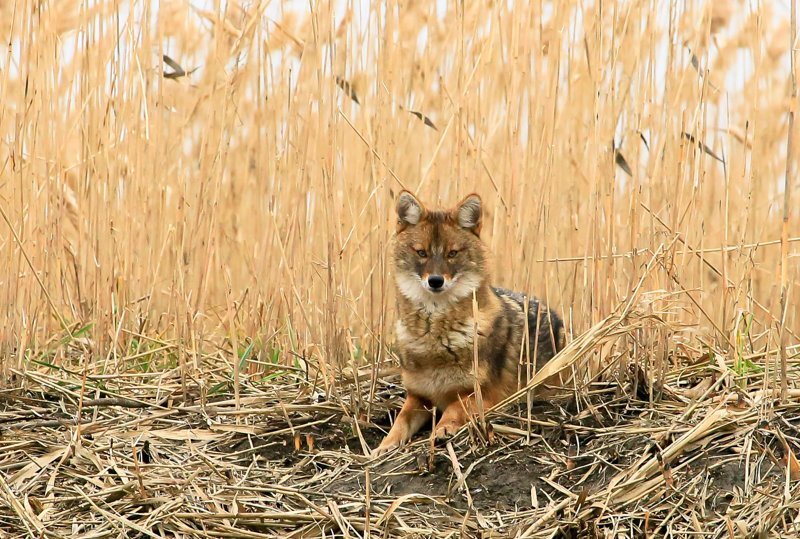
[{"x1": 217, "y1": 402, "x2": 620, "y2": 511}]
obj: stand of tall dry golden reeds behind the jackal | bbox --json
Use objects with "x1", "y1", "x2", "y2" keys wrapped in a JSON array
[{"x1": 0, "y1": 0, "x2": 800, "y2": 392}]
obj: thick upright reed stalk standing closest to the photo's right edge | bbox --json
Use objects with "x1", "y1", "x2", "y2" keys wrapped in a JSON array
[{"x1": 778, "y1": 2, "x2": 798, "y2": 402}]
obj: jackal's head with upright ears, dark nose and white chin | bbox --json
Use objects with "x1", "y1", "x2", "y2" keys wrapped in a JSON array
[{"x1": 394, "y1": 191, "x2": 488, "y2": 310}]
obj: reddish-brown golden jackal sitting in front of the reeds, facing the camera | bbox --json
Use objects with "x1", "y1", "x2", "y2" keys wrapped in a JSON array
[{"x1": 375, "y1": 191, "x2": 564, "y2": 453}]
